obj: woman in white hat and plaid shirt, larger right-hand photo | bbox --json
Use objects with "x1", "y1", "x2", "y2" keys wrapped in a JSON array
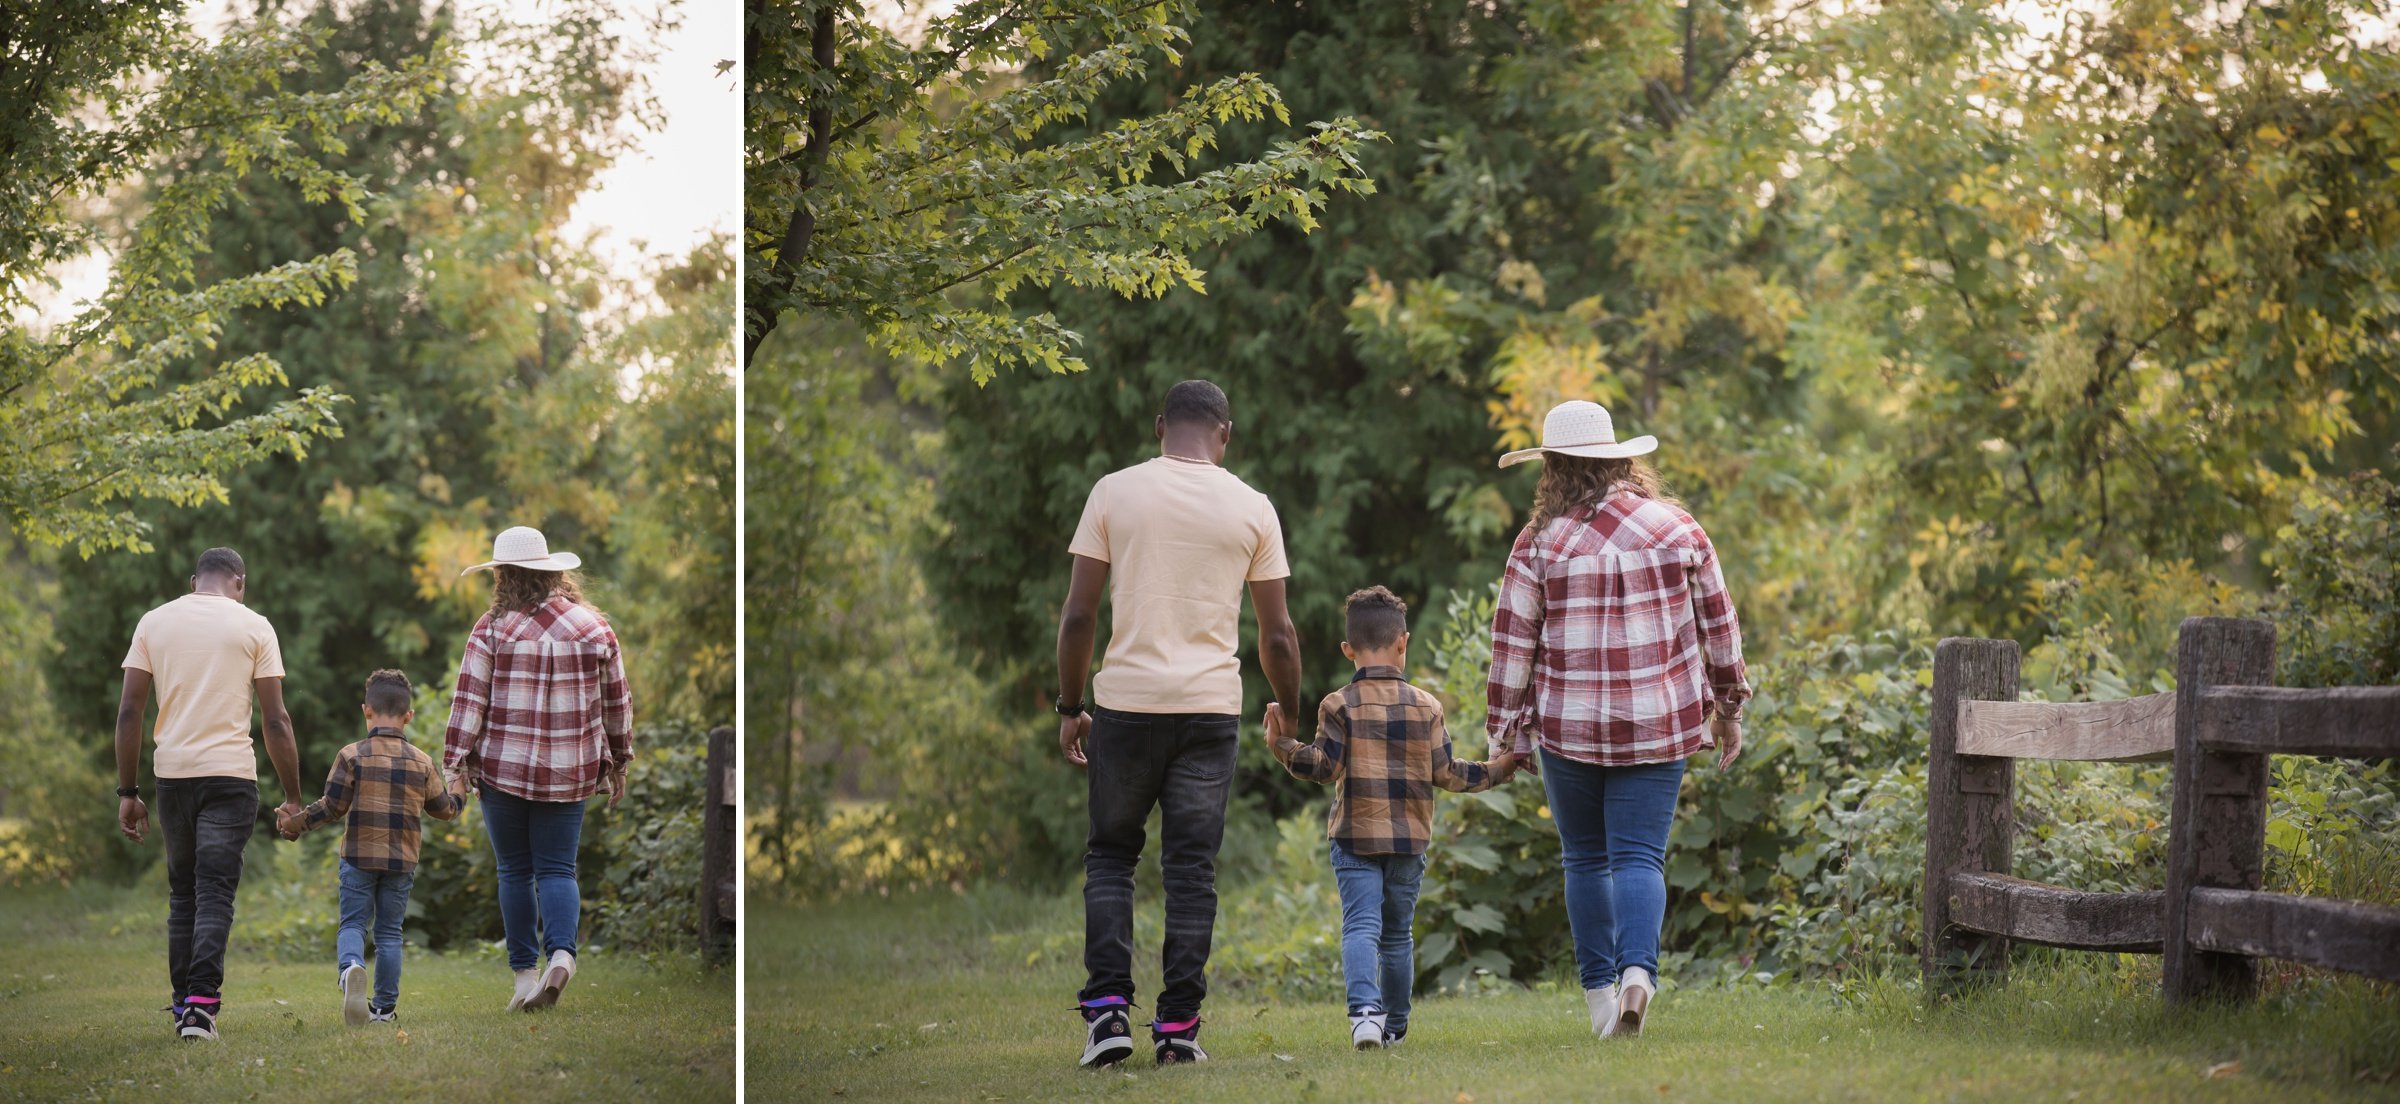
[{"x1": 1486, "y1": 401, "x2": 1750, "y2": 1034}]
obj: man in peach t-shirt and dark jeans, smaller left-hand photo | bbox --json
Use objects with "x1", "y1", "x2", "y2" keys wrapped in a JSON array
[{"x1": 118, "y1": 547, "x2": 300, "y2": 1039}]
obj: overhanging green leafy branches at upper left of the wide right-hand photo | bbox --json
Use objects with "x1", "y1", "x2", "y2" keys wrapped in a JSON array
[{"x1": 744, "y1": 0, "x2": 1380, "y2": 372}]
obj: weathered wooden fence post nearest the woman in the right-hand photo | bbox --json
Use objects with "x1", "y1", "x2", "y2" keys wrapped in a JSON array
[{"x1": 1925, "y1": 636, "x2": 2016, "y2": 996}]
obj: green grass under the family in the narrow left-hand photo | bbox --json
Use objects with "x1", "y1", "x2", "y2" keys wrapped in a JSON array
[{"x1": 0, "y1": 878, "x2": 734, "y2": 1102}]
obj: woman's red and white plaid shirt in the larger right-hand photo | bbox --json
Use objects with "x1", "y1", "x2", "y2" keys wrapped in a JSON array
[{"x1": 1486, "y1": 490, "x2": 1750, "y2": 766}]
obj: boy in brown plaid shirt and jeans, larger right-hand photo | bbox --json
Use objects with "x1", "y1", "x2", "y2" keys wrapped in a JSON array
[{"x1": 1267, "y1": 586, "x2": 1517, "y2": 1051}]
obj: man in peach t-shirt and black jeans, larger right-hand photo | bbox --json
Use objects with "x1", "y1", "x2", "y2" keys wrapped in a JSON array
[{"x1": 1058, "y1": 379, "x2": 1301, "y2": 1066}]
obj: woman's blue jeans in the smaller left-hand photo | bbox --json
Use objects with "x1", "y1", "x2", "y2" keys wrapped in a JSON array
[{"x1": 480, "y1": 787, "x2": 583, "y2": 970}]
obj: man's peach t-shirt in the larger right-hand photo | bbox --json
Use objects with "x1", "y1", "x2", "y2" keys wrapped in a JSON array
[{"x1": 1068, "y1": 456, "x2": 1291, "y2": 713}]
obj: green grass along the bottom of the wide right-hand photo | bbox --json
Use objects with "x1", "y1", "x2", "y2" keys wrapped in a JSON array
[{"x1": 746, "y1": 893, "x2": 2400, "y2": 1104}]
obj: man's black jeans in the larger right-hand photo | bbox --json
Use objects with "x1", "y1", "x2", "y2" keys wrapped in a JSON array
[{"x1": 1082, "y1": 708, "x2": 1241, "y2": 1022}]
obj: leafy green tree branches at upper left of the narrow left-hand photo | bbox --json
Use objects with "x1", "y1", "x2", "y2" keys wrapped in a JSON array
[{"x1": 0, "y1": 0, "x2": 439, "y2": 557}]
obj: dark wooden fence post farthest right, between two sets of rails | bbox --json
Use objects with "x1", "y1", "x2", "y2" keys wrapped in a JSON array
[{"x1": 2162, "y1": 617, "x2": 2275, "y2": 1006}]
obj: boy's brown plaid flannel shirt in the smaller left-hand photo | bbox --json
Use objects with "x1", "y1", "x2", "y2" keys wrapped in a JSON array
[{"x1": 300, "y1": 727, "x2": 466, "y2": 874}]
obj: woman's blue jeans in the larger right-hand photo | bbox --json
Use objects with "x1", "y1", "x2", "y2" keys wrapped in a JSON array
[{"x1": 1541, "y1": 751, "x2": 1682, "y2": 989}]
